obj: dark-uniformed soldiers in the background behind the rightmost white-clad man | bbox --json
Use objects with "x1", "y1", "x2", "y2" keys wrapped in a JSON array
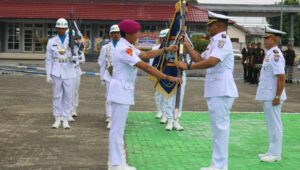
[{"x1": 241, "y1": 43, "x2": 296, "y2": 84}]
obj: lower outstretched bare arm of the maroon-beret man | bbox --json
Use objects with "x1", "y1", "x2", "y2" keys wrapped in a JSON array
[{"x1": 135, "y1": 61, "x2": 182, "y2": 84}]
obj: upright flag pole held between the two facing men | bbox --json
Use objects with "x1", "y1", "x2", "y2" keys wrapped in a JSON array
[{"x1": 174, "y1": 0, "x2": 187, "y2": 120}]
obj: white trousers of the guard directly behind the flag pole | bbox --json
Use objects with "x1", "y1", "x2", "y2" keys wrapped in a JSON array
[{"x1": 163, "y1": 73, "x2": 186, "y2": 119}]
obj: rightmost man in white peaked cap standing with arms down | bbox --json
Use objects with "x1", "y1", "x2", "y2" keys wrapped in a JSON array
[{"x1": 256, "y1": 27, "x2": 287, "y2": 162}]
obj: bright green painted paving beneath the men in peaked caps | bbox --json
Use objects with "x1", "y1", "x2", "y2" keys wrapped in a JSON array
[{"x1": 125, "y1": 112, "x2": 300, "y2": 170}]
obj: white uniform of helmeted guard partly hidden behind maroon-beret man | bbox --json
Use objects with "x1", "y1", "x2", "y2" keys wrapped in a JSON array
[{"x1": 98, "y1": 42, "x2": 115, "y2": 118}]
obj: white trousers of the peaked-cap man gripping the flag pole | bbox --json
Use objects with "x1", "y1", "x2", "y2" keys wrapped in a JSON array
[{"x1": 206, "y1": 97, "x2": 235, "y2": 169}]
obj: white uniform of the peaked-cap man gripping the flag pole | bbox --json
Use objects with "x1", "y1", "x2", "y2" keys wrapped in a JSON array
[{"x1": 201, "y1": 32, "x2": 238, "y2": 169}]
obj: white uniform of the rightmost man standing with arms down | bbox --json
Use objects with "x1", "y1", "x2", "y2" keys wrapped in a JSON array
[{"x1": 256, "y1": 46, "x2": 287, "y2": 156}]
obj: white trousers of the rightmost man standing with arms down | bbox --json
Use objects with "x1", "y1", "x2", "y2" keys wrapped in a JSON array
[{"x1": 264, "y1": 101, "x2": 283, "y2": 156}]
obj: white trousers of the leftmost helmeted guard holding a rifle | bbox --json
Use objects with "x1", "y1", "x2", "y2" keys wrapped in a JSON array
[{"x1": 51, "y1": 76, "x2": 74, "y2": 118}]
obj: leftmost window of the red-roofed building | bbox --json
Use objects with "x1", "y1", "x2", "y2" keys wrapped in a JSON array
[{"x1": 7, "y1": 23, "x2": 20, "y2": 51}]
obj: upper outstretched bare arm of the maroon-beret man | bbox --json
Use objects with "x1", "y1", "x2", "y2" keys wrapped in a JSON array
[{"x1": 139, "y1": 45, "x2": 178, "y2": 60}]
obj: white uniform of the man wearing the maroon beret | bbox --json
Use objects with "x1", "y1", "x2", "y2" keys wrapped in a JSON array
[{"x1": 108, "y1": 38, "x2": 141, "y2": 166}]
